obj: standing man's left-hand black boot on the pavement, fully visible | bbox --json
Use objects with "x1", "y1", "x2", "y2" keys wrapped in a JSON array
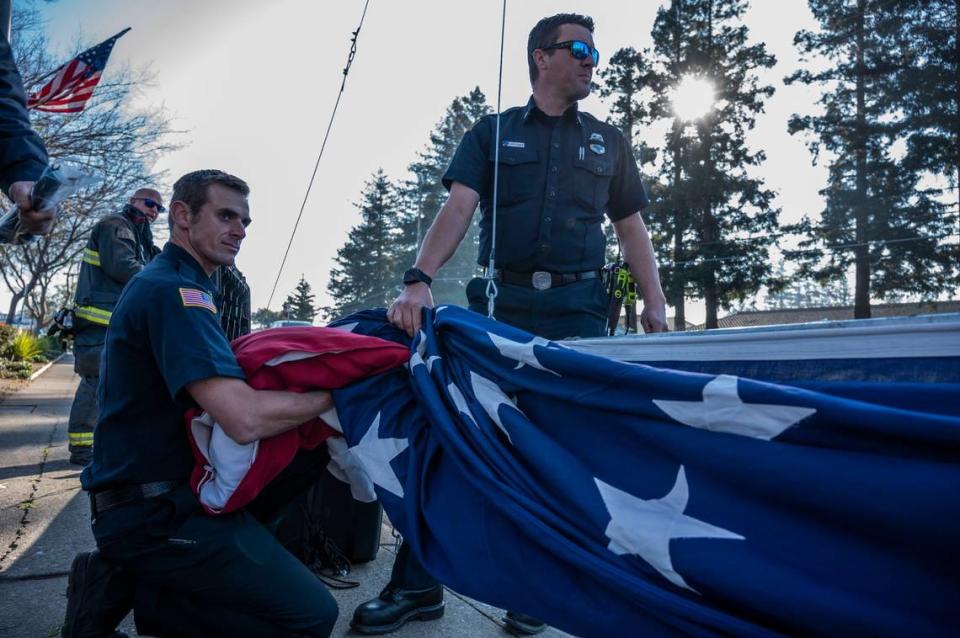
[{"x1": 350, "y1": 585, "x2": 444, "y2": 634}]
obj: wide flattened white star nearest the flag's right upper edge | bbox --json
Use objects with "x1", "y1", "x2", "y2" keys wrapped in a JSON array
[{"x1": 653, "y1": 374, "x2": 816, "y2": 441}]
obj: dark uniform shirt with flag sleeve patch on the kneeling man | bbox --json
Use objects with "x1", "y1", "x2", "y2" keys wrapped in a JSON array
[{"x1": 81, "y1": 242, "x2": 245, "y2": 491}]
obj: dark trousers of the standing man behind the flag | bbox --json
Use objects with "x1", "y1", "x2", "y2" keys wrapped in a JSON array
[{"x1": 389, "y1": 277, "x2": 608, "y2": 589}]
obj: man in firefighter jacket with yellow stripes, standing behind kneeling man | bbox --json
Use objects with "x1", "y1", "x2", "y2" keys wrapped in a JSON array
[{"x1": 67, "y1": 188, "x2": 166, "y2": 465}]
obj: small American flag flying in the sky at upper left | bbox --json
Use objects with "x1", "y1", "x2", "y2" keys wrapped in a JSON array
[{"x1": 27, "y1": 27, "x2": 130, "y2": 113}]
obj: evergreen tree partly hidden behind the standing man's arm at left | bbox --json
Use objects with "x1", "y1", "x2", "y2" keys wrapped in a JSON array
[{"x1": 393, "y1": 87, "x2": 491, "y2": 305}]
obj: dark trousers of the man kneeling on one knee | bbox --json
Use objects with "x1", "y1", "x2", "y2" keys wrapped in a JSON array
[{"x1": 93, "y1": 445, "x2": 337, "y2": 638}]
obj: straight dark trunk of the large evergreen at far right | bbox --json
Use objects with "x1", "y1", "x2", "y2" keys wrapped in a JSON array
[{"x1": 853, "y1": 0, "x2": 870, "y2": 319}]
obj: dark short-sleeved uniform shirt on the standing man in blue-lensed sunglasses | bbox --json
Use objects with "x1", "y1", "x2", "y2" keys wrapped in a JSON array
[{"x1": 443, "y1": 97, "x2": 648, "y2": 273}]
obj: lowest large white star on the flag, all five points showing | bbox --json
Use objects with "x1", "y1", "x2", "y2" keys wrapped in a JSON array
[{"x1": 593, "y1": 466, "x2": 743, "y2": 593}]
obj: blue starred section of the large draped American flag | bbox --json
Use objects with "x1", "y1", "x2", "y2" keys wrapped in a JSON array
[{"x1": 323, "y1": 306, "x2": 960, "y2": 638}]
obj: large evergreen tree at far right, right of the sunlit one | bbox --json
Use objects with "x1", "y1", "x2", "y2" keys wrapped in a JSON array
[{"x1": 786, "y1": 0, "x2": 955, "y2": 318}]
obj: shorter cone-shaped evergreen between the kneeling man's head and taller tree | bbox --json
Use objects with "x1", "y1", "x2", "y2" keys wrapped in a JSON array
[{"x1": 325, "y1": 169, "x2": 402, "y2": 319}]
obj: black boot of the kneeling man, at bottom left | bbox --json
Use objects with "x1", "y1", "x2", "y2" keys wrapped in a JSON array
[{"x1": 60, "y1": 550, "x2": 133, "y2": 638}]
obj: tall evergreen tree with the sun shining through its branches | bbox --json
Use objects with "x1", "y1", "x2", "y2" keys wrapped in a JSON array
[{"x1": 620, "y1": 0, "x2": 779, "y2": 328}]
